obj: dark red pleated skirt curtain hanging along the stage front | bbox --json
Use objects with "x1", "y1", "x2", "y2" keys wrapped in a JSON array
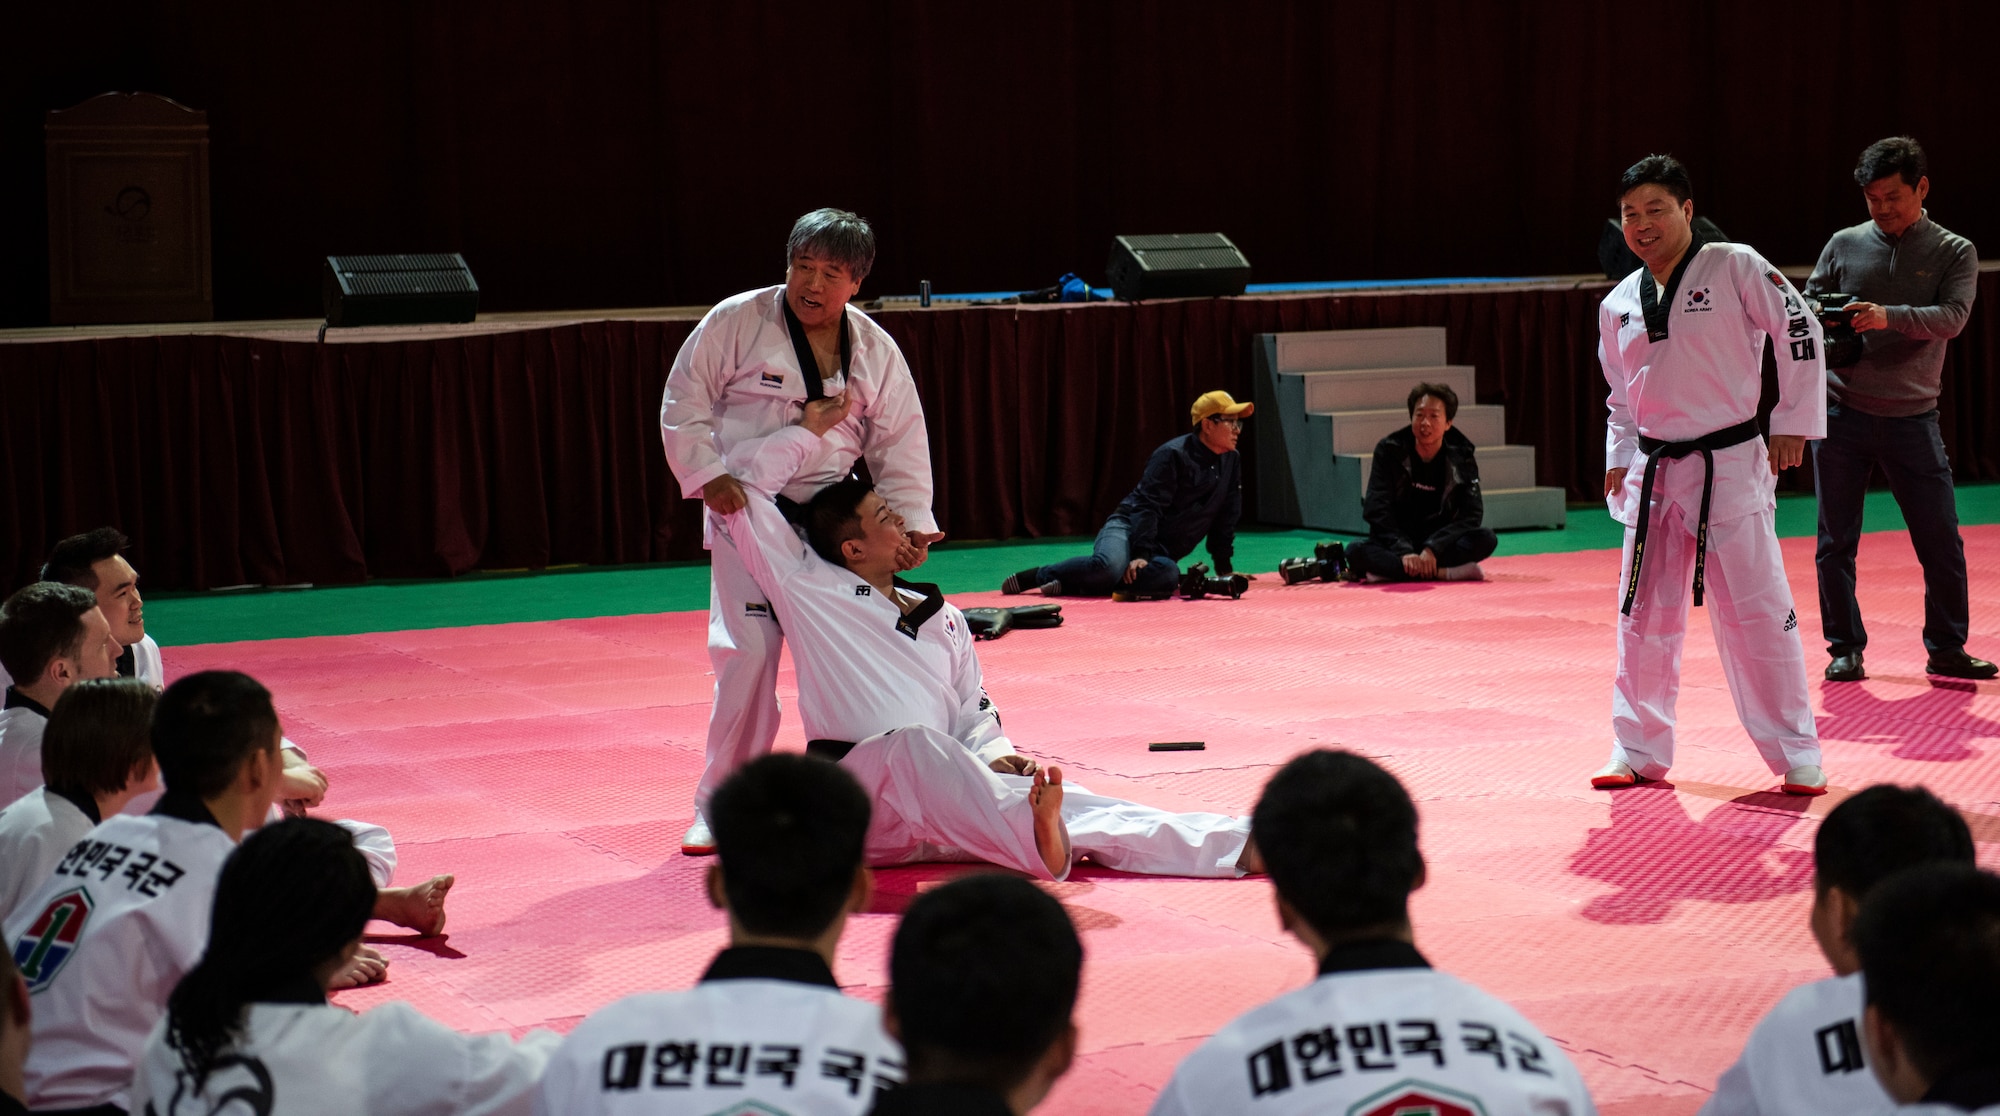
[{"x1": 0, "y1": 270, "x2": 2000, "y2": 588}]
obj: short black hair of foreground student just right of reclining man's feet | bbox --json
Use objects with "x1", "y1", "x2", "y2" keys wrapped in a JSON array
[{"x1": 1250, "y1": 748, "x2": 1424, "y2": 940}]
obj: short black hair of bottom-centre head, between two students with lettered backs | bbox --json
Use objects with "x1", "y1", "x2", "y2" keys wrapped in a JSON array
[{"x1": 888, "y1": 872, "x2": 1084, "y2": 1092}]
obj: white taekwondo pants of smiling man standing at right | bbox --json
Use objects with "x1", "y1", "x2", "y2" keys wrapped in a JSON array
[{"x1": 1612, "y1": 504, "x2": 1820, "y2": 778}]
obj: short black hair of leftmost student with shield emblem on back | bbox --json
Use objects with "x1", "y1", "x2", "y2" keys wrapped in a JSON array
[{"x1": 152, "y1": 670, "x2": 278, "y2": 798}]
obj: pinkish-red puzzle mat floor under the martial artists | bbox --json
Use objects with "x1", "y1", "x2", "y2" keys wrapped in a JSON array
[{"x1": 166, "y1": 526, "x2": 2000, "y2": 1114}]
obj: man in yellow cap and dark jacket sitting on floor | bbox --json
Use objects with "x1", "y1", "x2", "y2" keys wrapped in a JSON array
[{"x1": 1000, "y1": 392, "x2": 1254, "y2": 600}]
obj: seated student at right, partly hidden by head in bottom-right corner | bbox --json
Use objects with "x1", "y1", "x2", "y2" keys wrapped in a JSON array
[{"x1": 1702, "y1": 784, "x2": 1974, "y2": 1116}]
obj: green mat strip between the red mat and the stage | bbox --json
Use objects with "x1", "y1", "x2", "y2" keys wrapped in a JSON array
[{"x1": 146, "y1": 484, "x2": 2000, "y2": 646}]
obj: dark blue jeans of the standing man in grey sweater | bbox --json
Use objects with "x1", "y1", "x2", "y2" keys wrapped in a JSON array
[{"x1": 1812, "y1": 404, "x2": 1970, "y2": 656}]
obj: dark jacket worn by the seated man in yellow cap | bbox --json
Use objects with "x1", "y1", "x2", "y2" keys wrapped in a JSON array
[{"x1": 1112, "y1": 430, "x2": 1244, "y2": 574}]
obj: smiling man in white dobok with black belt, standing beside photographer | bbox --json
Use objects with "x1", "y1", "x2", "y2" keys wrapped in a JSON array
[{"x1": 1590, "y1": 156, "x2": 1826, "y2": 794}]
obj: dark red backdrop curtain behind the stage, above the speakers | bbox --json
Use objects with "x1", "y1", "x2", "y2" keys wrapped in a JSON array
[{"x1": 0, "y1": 0, "x2": 2000, "y2": 326}]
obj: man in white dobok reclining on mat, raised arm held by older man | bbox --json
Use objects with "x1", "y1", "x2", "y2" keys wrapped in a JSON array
[{"x1": 718, "y1": 396, "x2": 1256, "y2": 880}]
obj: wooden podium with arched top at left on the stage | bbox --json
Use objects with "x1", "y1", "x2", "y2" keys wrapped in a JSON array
[{"x1": 46, "y1": 92, "x2": 216, "y2": 326}]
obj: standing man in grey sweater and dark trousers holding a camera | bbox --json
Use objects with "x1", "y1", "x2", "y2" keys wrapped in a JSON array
[{"x1": 1806, "y1": 136, "x2": 2000, "y2": 682}]
